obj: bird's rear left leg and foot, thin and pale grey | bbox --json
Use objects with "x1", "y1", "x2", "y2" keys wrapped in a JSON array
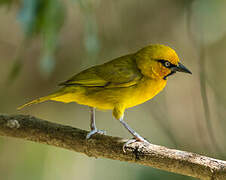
[{"x1": 86, "y1": 107, "x2": 106, "y2": 139}]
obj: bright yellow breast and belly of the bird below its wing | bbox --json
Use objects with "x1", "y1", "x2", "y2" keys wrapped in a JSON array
[{"x1": 51, "y1": 79, "x2": 166, "y2": 109}]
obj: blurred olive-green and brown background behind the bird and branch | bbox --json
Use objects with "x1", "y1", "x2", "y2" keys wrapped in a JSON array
[{"x1": 0, "y1": 0, "x2": 226, "y2": 180}]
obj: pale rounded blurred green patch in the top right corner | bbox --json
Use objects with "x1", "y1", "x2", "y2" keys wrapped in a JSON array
[{"x1": 191, "y1": 0, "x2": 226, "y2": 45}]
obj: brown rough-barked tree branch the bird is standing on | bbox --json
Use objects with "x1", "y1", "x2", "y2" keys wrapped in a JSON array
[{"x1": 0, "y1": 115, "x2": 226, "y2": 180}]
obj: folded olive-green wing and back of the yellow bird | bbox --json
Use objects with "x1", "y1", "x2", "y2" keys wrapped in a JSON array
[{"x1": 60, "y1": 55, "x2": 142, "y2": 88}]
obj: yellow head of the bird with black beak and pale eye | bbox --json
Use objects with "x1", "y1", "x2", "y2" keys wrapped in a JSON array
[{"x1": 135, "y1": 44, "x2": 191, "y2": 80}]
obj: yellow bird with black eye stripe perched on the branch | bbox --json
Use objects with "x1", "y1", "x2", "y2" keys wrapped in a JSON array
[{"x1": 18, "y1": 44, "x2": 191, "y2": 142}]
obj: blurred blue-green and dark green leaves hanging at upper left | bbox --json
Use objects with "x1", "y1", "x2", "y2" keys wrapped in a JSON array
[{"x1": 18, "y1": 0, "x2": 65, "y2": 76}]
